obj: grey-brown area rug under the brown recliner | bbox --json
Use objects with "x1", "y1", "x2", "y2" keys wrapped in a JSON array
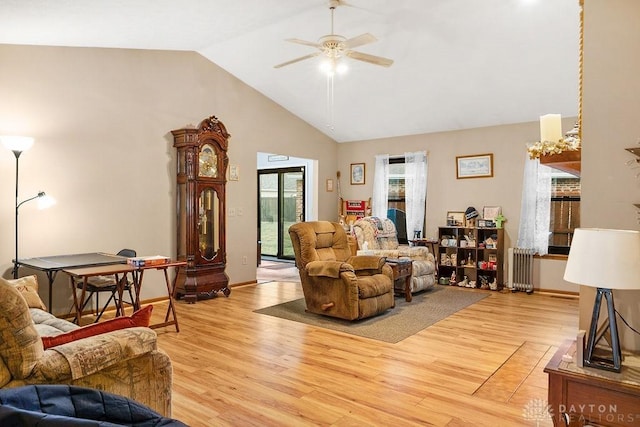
[{"x1": 254, "y1": 285, "x2": 490, "y2": 343}]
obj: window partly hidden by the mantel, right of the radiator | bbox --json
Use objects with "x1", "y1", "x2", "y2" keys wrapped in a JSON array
[{"x1": 549, "y1": 172, "x2": 580, "y2": 255}]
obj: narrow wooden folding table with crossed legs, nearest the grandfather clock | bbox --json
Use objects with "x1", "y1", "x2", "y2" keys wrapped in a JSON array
[{"x1": 62, "y1": 261, "x2": 187, "y2": 332}]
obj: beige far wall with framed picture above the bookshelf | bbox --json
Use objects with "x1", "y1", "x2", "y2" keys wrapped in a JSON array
[{"x1": 338, "y1": 120, "x2": 578, "y2": 292}]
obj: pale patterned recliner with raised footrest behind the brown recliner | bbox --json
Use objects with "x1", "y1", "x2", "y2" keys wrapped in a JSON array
[{"x1": 353, "y1": 217, "x2": 436, "y2": 294}]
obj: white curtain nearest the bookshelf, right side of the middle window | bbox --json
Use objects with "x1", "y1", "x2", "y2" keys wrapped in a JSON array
[{"x1": 404, "y1": 151, "x2": 427, "y2": 239}]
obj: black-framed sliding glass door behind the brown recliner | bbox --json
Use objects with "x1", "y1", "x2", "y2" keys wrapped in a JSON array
[{"x1": 258, "y1": 166, "x2": 305, "y2": 260}]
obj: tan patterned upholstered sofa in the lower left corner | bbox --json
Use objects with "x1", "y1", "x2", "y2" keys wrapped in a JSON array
[{"x1": 0, "y1": 278, "x2": 172, "y2": 417}]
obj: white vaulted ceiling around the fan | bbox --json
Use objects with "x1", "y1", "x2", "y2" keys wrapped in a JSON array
[{"x1": 0, "y1": 0, "x2": 580, "y2": 142}]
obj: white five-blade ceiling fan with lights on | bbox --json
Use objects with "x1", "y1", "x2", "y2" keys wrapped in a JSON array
[{"x1": 274, "y1": 0, "x2": 393, "y2": 69}]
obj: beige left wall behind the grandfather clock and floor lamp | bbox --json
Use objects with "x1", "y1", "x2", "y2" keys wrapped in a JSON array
[{"x1": 0, "y1": 45, "x2": 337, "y2": 313}]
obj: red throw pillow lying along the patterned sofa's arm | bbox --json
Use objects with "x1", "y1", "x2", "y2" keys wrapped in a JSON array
[{"x1": 42, "y1": 305, "x2": 153, "y2": 350}]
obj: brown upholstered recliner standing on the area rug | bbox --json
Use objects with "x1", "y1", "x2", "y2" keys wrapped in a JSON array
[{"x1": 289, "y1": 221, "x2": 395, "y2": 320}]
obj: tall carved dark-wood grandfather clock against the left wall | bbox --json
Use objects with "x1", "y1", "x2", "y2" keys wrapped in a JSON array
[{"x1": 171, "y1": 116, "x2": 231, "y2": 303}]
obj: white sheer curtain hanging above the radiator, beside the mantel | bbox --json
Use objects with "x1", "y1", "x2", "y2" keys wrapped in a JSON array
[{"x1": 518, "y1": 155, "x2": 551, "y2": 255}]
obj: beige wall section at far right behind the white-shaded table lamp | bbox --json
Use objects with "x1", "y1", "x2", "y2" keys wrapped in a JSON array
[{"x1": 580, "y1": 0, "x2": 640, "y2": 350}]
